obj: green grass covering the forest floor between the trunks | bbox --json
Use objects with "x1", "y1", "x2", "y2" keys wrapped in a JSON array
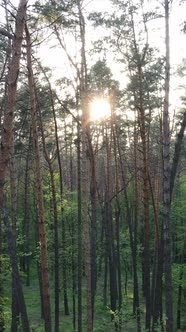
[{"x1": 4, "y1": 268, "x2": 185, "y2": 332}]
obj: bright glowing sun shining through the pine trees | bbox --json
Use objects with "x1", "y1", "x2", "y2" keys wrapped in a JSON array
[{"x1": 90, "y1": 98, "x2": 111, "y2": 121}]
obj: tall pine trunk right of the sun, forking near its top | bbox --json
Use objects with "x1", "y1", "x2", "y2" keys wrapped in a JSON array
[{"x1": 131, "y1": 9, "x2": 151, "y2": 331}]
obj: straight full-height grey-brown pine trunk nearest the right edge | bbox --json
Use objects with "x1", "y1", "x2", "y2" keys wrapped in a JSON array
[{"x1": 163, "y1": 0, "x2": 173, "y2": 332}]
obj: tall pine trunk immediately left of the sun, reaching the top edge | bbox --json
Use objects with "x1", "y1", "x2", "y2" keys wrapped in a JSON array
[{"x1": 77, "y1": 0, "x2": 93, "y2": 332}]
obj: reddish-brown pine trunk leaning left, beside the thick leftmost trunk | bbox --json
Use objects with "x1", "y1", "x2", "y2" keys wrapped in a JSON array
[{"x1": 25, "y1": 25, "x2": 52, "y2": 332}]
